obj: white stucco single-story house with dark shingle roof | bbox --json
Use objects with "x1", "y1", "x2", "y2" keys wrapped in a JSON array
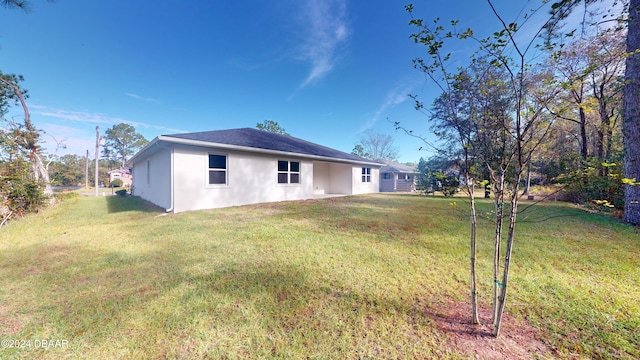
[{"x1": 129, "y1": 128, "x2": 383, "y2": 213}]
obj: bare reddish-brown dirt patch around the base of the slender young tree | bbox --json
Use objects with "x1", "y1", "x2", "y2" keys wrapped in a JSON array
[{"x1": 424, "y1": 302, "x2": 554, "y2": 359}]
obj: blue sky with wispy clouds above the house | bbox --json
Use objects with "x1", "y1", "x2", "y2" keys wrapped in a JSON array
[{"x1": 0, "y1": 0, "x2": 608, "y2": 162}]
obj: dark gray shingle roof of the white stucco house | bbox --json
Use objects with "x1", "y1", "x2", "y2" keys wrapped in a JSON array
[{"x1": 164, "y1": 128, "x2": 375, "y2": 163}]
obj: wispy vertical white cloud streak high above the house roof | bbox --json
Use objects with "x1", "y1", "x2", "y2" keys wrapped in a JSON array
[{"x1": 300, "y1": 0, "x2": 349, "y2": 88}]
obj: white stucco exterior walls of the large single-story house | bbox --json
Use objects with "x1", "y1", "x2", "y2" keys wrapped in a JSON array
[{"x1": 133, "y1": 144, "x2": 379, "y2": 212}]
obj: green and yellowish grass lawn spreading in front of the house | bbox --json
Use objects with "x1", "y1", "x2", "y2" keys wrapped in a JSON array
[{"x1": 0, "y1": 194, "x2": 640, "y2": 359}]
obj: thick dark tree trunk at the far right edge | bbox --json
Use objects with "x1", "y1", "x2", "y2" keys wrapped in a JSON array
[{"x1": 622, "y1": 0, "x2": 640, "y2": 225}]
